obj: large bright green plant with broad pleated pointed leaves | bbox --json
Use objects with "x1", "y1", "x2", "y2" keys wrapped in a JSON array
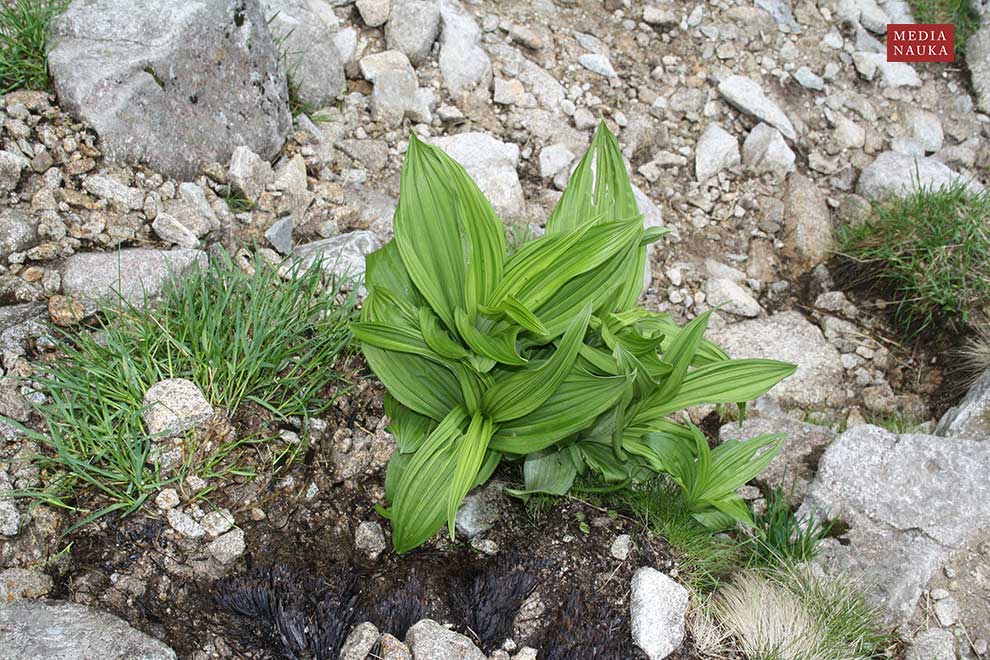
[{"x1": 352, "y1": 124, "x2": 794, "y2": 552}]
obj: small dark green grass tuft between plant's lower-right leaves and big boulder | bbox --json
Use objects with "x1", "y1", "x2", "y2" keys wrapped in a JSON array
[{"x1": 749, "y1": 488, "x2": 832, "y2": 566}]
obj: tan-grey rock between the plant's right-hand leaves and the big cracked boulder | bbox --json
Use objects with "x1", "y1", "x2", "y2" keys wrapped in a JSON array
[{"x1": 719, "y1": 415, "x2": 836, "y2": 502}]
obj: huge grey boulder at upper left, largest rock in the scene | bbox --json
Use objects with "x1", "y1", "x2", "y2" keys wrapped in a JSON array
[{"x1": 48, "y1": 0, "x2": 292, "y2": 179}]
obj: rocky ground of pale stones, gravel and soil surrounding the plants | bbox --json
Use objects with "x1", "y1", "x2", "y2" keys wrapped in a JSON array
[{"x1": 0, "y1": 0, "x2": 990, "y2": 658}]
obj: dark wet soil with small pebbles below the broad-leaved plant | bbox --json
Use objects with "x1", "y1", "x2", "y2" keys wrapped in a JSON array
[{"x1": 44, "y1": 364, "x2": 697, "y2": 658}]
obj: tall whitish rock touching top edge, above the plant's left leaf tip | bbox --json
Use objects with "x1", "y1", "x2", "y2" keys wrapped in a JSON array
[{"x1": 439, "y1": 0, "x2": 492, "y2": 96}]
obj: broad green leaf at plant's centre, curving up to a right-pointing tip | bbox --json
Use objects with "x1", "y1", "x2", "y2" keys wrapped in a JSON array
[{"x1": 482, "y1": 306, "x2": 591, "y2": 424}]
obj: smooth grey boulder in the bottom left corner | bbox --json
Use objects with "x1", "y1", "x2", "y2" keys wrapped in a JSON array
[{"x1": 0, "y1": 599, "x2": 176, "y2": 660}]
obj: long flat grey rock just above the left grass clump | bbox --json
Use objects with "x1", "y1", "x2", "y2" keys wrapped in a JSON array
[{"x1": 60, "y1": 248, "x2": 206, "y2": 305}]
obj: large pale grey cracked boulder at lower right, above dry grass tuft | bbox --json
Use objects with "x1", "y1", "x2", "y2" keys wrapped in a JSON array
[{"x1": 801, "y1": 425, "x2": 990, "y2": 624}]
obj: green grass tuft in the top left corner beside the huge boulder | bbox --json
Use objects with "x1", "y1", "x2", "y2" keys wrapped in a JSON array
[{"x1": 0, "y1": 0, "x2": 68, "y2": 94}]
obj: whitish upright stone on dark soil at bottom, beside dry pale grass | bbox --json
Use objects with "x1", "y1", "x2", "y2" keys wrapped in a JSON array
[{"x1": 629, "y1": 567, "x2": 688, "y2": 660}]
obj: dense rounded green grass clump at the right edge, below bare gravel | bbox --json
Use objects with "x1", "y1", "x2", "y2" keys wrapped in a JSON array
[{"x1": 838, "y1": 183, "x2": 990, "y2": 336}]
